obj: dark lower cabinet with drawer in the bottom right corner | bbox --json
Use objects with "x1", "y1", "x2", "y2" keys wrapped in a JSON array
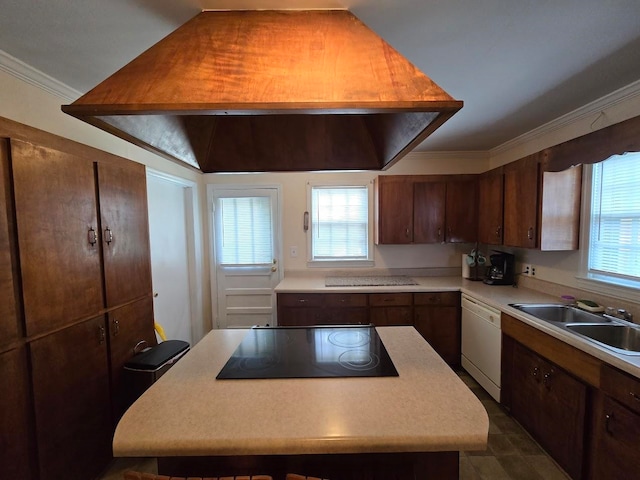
[{"x1": 590, "y1": 365, "x2": 640, "y2": 480}]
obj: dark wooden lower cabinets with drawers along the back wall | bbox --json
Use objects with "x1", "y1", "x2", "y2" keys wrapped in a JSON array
[{"x1": 278, "y1": 292, "x2": 460, "y2": 366}]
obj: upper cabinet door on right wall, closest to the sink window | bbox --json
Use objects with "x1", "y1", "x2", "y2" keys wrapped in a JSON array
[{"x1": 504, "y1": 155, "x2": 539, "y2": 248}]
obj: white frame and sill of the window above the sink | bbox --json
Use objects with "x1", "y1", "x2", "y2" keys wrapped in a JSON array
[{"x1": 576, "y1": 155, "x2": 640, "y2": 301}]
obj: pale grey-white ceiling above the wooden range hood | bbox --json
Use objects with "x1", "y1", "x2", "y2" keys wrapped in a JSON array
[{"x1": 0, "y1": 0, "x2": 640, "y2": 151}]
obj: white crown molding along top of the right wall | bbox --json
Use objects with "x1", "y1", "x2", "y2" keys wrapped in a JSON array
[{"x1": 488, "y1": 80, "x2": 640, "y2": 157}]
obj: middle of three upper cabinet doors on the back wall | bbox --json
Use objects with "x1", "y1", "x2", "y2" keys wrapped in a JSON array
[{"x1": 413, "y1": 182, "x2": 447, "y2": 243}]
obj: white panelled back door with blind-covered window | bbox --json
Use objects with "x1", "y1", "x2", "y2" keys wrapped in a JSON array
[{"x1": 210, "y1": 185, "x2": 282, "y2": 328}]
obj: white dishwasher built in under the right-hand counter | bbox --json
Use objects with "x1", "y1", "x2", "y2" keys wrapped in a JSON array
[{"x1": 462, "y1": 293, "x2": 502, "y2": 402}]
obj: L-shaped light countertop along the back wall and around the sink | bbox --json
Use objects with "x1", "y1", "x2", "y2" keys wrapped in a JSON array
[{"x1": 275, "y1": 275, "x2": 640, "y2": 378}]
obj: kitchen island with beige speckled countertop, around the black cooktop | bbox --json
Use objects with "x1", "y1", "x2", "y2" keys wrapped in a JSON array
[{"x1": 113, "y1": 327, "x2": 489, "y2": 479}]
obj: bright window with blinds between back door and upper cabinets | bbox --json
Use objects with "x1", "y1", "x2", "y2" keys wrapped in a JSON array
[{"x1": 309, "y1": 185, "x2": 371, "y2": 262}]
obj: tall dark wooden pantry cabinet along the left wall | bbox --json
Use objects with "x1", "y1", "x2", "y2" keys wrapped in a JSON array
[{"x1": 0, "y1": 118, "x2": 156, "y2": 480}]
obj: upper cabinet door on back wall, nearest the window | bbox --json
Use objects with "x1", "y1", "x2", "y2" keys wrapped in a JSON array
[{"x1": 375, "y1": 175, "x2": 413, "y2": 244}]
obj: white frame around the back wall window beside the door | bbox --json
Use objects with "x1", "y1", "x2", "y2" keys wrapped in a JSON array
[{"x1": 305, "y1": 181, "x2": 375, "y2": 268}]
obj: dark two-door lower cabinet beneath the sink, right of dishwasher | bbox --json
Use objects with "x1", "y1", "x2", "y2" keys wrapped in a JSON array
[{"x1": 503, "y1": 336, "x2": 588, "y2": 479}]
